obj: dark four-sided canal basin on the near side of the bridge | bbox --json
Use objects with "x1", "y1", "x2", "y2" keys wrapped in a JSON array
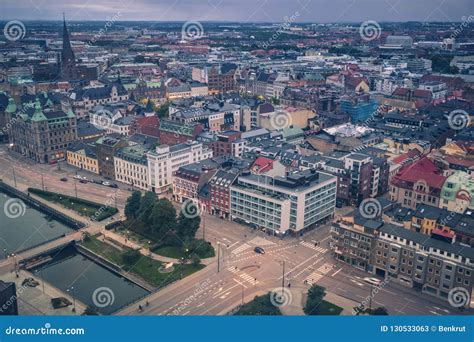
[{"x1": 31, "y1": 247, "x2": 149, "y2": 314}]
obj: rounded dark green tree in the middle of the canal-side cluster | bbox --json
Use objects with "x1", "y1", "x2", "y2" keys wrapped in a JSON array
[{"x1": 150, "y1": 198, "x2": 176, "y2": 240}]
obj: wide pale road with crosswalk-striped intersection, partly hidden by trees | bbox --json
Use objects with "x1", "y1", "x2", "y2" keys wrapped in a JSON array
[{"x1": 0, "y1": 147, "x2": 466, "y2": 315}]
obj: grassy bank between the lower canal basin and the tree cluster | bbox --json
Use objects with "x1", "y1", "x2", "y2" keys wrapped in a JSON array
[{"x1": 82, "y1": 237, "x2": 205, "y2": 288}]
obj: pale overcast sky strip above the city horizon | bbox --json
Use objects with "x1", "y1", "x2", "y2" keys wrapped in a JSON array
[{"x1": 0, "y1": 0, "x2": 474, "y2": 25}]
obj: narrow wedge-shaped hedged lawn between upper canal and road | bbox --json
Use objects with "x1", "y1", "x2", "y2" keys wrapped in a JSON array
[{"x1": 28, "y1": 188, "x2": 118, "y2": 221}]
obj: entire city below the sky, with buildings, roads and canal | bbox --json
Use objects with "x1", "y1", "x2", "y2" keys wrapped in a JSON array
[{"x1": 0, "y1": 0, "x2": 474, "y2": 322}]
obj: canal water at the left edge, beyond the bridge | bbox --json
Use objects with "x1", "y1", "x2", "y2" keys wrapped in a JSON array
[{"x1": 0, "y1": 192, "x2": 72, "y2": 259}]
